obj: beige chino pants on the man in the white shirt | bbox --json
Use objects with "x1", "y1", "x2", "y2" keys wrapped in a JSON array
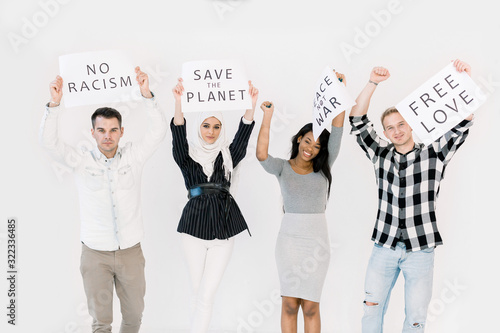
[{"x1": 80, "y1": 243, "x2": 146, "y2": 333}]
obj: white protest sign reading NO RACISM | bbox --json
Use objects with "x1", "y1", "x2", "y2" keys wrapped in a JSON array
[{"x1": 59, "y1": 51, "x2": 141, "y2": 107}]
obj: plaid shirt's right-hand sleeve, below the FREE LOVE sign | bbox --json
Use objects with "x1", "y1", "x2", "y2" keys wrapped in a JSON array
[{"x1": 431, "y1": 119, "x2": 473, "y2": 165}]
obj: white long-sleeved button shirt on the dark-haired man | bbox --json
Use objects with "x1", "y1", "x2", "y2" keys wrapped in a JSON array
[{"x1": 40, "y1": 98, "x2": 167, "y2": 251}]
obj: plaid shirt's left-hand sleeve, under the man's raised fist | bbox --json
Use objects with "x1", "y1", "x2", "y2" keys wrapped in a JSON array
[{"x1": 349, "y1": 115, "x2": 389, "y2": 163}]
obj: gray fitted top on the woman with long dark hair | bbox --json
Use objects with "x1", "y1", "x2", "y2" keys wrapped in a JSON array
[{"x1": 260, "y1": 126, "x2": 344, "y2": 214}]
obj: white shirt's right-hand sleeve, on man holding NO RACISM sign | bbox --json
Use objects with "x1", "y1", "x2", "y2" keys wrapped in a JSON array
[{"x1": 132, "y1": 93, "x2": 167, "y2": 161}]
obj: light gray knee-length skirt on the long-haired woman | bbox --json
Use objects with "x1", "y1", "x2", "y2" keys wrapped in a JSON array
[{"x1": 275, "y1": 213, "x2": 330, "y2": 302}]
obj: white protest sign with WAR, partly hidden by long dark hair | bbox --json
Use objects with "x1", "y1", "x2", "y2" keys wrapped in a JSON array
[{"x1": 312, "y1": 67, "x2": 356, "y2": 140}]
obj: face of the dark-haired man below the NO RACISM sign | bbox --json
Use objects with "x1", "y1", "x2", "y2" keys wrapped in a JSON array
[{"x1": 91, "y1": 116, "x2": 123, "y2": 158}]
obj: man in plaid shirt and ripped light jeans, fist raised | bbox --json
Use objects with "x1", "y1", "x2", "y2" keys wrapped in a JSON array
[{"x1": 349, "y1": 60, "x2": 472, "y2": 333}]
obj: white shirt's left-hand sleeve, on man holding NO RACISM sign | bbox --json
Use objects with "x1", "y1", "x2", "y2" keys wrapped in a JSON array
[{"x1": 39, "y1": 104, "x2": 82, "y2": 168}]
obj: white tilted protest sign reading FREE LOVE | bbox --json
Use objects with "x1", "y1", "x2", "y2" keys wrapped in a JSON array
[{"x1": 396, "y1": 63, "x2": 486, "y2": 145}]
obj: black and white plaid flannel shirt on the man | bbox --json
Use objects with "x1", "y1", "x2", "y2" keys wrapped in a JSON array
[{"x1": 349, "y1": 115, "x2": 472, "y2": 252}]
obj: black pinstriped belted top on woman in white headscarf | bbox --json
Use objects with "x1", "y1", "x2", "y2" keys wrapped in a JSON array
[{"x1": 170, "y1": 119, "x2": 255, "y2": 240}]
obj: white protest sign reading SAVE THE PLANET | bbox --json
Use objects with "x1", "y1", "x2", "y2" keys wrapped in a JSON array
[{"x1": 181, "y1": 60, "x2": 252, "y2": 112}]
